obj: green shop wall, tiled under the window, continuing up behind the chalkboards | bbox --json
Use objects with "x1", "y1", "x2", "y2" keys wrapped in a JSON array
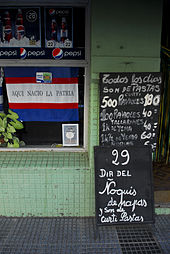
[{"x1": 0, "y1": 0, "x2": 161, "y2": 216}]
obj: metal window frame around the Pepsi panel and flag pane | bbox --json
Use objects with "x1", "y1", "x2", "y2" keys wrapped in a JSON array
[{"x1": 0, "y1": 0, "x2": 90, "y2": 152}]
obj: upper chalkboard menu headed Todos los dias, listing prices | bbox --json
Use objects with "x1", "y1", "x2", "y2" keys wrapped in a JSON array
[{"x1": 99, "y1": 72, "x2": 161, "y2": 151}]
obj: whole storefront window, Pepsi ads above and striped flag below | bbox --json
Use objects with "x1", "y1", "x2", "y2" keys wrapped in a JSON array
[{"x1": 0, "y1": 1, "x2": 88, "y2": 147}]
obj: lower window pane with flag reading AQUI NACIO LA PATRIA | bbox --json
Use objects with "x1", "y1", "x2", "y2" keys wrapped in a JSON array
[{"x1": 3, "y1": 67, "x2": 84, "y2": 146}]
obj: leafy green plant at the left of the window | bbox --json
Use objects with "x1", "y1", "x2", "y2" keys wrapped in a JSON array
[{"x1": 0, "y1": 109, "x2": 24, "y2": 148}]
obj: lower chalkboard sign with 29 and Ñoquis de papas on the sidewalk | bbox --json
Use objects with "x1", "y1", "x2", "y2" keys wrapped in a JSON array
[{"x1": 94, "y1": 146, "x2": 154, "y2": 225}]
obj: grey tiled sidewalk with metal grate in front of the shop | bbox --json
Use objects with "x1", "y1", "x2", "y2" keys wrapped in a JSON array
[{"x1": 0, "y1": 215, "x2": 170, "y2": 254}]
